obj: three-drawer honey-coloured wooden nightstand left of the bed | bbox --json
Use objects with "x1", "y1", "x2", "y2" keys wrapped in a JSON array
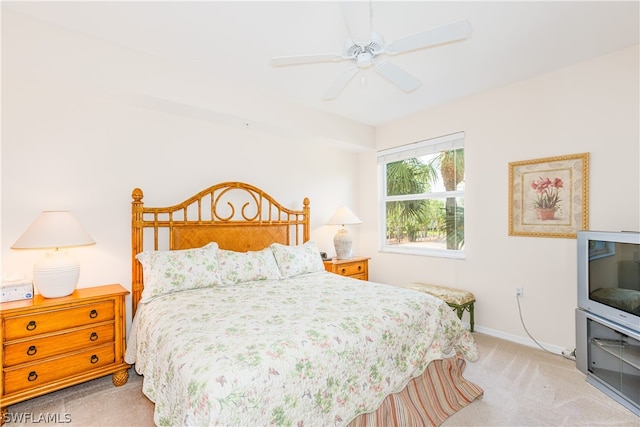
[{"x1": 0, "y1": 285, "x2": 129, "y2": 424}]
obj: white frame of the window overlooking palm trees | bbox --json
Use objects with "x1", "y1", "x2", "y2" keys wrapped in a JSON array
[{"x1": 378, "y1": 132, "x2": 465, "y2": 259}]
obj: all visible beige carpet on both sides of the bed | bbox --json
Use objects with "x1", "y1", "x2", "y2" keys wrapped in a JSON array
[{"x1": 5, "y1": 333, "x2": 640, "y2": 427}]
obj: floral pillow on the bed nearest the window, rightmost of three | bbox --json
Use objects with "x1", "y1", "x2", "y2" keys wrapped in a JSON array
[{"x1": 271, "y1": 240, "x2": 324, "y2": 278}]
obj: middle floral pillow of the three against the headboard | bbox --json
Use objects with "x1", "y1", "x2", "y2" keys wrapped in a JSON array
[{"x1": 218, "y1": 248, "x2": 280, "y2": 285}]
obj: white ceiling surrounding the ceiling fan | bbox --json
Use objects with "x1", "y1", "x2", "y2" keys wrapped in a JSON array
[{"x1": 2, "y1": 1, "x2": 640, "y2": 126}]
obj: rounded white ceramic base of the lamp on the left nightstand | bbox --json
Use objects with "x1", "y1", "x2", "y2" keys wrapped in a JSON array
[{"x1": 33, "y1": 251, "x2": 80, "y2": 298}]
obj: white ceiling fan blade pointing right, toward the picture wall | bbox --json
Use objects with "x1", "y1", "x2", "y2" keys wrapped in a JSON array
[{"x1": 386, "y1": 19, "x2": 471, "y2": 55}]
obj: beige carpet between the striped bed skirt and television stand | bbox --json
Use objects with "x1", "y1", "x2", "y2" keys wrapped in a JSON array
[{"x1": 442, "y1": 333, "x2": 640, "y2": 427}]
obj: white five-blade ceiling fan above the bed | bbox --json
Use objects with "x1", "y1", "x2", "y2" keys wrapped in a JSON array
[{"x1": 271, "y1": 1, "x2": 471, "y2": 100}]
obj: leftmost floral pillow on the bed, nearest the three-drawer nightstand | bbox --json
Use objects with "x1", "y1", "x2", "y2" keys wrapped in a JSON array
[{"x1": 136, "y1": 242, "x2": 222, "y2": 302}]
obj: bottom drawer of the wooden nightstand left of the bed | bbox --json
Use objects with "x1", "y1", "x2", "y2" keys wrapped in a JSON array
[{"x1": 4, "y1": 343, "x2": 115, "y2": 394}]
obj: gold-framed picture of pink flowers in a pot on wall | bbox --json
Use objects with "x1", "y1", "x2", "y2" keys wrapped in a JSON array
[{"x1": 509, "y1": 153, "x2": 589, "y2": 238}]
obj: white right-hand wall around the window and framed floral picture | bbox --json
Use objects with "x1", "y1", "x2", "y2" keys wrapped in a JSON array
[{"x1": 358, "y1": 46, "x2": 640, "y2": 349}]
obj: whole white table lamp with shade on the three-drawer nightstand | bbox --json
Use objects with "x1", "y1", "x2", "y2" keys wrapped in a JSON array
[{"x1": 11, "y1": 211, "x2": 96, "y2": 298}]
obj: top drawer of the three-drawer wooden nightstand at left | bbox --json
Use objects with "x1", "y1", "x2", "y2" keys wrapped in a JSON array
[{"x1": 4, "y1": 300, "x2": 115, "y2": 341}]
